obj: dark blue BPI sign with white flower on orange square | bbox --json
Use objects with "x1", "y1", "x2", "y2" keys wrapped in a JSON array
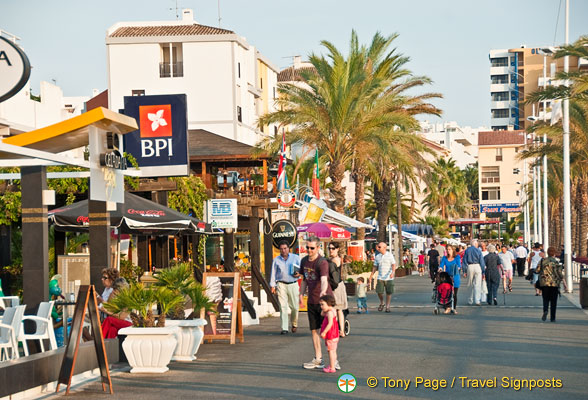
[{"x1": 122, "y1": 94, "x2": 189, "y2": 176}]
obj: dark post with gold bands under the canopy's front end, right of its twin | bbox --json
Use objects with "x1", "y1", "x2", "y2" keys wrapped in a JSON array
[{"x1": 88, "y1": 200, "x2": 110, "y2": 291}]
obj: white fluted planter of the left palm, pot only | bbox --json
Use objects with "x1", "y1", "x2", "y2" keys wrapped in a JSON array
[{"x1": 118, "y1": 327, "x2": 177, "y2": 374}]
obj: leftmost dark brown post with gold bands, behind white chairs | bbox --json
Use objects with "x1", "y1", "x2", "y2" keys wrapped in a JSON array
[{"x1": 20, "y1": 167, "x2": 49, "y2": 309}]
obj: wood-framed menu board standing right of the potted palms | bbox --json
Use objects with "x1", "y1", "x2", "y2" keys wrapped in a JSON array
[{"x1": 201, "y1": 272, "x2": 244, "y2": 344}]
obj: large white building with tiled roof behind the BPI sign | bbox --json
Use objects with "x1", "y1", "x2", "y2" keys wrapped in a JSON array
[{"x1": 106, "y1": 9, "x2": 278, "y2": 145}]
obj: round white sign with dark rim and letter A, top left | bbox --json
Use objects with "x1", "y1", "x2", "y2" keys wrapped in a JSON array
[{"x1": 0, "y1": 36, "x2": 31, "y2": 103}]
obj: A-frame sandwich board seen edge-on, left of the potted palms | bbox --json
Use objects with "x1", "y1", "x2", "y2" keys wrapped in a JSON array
[{"x1": 55, "y1": 285, "x2": 113, "y2": 394}]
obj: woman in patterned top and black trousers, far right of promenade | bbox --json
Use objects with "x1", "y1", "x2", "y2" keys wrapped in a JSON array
[{"x1": 535, "y1": 247, "x2": 563, "y2": 322}]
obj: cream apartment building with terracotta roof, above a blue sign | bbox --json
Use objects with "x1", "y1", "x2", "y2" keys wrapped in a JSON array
[{"x1": 478, "y1": 130, "x2": 532, "y2": 219}]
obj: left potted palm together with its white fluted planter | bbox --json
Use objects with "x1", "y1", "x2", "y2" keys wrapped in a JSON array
[{"x1": 104, "y1": 283, "x2": 183, "y2": 373}]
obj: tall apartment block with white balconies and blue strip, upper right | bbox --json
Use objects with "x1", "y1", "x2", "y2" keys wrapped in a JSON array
[{"x1": 490, "y1": 46, "x2": 586, "y2": 131}]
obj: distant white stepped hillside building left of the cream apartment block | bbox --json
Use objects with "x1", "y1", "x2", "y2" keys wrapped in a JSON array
[{"x1": 419, "y1": 121, "x2": 489, "y2": 169}]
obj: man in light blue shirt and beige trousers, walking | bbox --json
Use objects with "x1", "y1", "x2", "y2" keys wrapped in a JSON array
[{"x1": 270, "y1": 241, "x2": 300, "y2": 335}]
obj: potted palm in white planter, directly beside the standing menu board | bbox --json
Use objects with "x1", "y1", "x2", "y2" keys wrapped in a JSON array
[{"x1": 154, "y1": 263, "x2": 214, "y2": 361}]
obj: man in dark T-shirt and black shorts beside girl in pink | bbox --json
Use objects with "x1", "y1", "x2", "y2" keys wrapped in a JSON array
[{"x1": 300, "y1": 236, "x2": 339, "y2": 369}]
